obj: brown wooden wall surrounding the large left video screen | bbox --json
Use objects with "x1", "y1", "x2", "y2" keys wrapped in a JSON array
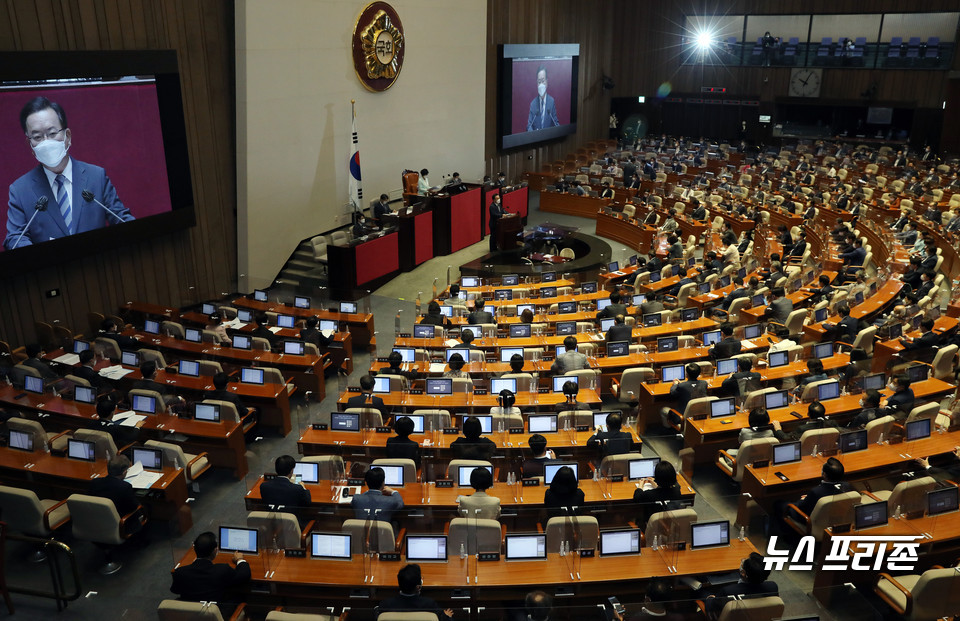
[{"x1": 0, "y1": 0, "x2": 237, "y2": 346}]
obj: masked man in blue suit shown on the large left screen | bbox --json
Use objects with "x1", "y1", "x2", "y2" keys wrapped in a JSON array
[{"x1": 3, "y1": 97, "x2": 134, "y2": 250}]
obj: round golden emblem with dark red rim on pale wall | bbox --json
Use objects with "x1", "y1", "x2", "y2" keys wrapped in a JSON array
[{"x1": 353, "y1": 2, "x2": 406, "y2": 91}]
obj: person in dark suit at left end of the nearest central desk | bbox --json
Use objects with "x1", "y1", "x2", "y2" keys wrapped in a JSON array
[{"x1": 170, "y1": 531, "x2": 250, "y2": 618}]
